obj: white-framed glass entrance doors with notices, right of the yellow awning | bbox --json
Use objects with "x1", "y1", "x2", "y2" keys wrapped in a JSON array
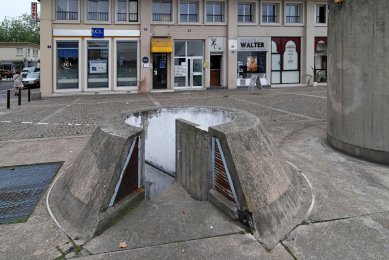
[{"x1": 174, "y1": 40, "x2": 204, "y2": 89}]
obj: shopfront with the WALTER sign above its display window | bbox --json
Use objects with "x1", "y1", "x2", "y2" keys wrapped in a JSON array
[{"x1": 237, "y1": 37, "x2": 270, "y2": 87}]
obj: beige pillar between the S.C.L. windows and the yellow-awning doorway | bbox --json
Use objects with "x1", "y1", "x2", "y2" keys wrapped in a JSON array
[{"x1": 139, "y1": 0, "x2": 153, "y2": 92}]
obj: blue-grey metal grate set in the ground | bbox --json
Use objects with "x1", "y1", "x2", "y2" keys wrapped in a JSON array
[{"x1": 0, "y1": 163, "x2": 62, "y2": 224}]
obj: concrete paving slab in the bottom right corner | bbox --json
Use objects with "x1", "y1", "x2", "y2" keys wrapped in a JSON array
[{"x1": 284, "y1": 213, "x2": 389, "y2": 260}]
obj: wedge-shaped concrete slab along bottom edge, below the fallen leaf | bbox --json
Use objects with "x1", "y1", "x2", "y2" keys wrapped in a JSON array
[{"x1": 81, "y1": 234, "x2": 293, "y2": 260}]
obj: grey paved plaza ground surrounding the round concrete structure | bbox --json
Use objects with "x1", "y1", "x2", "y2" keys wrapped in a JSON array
[{"x1": 0, "y1": 87, "x2": 389, "y2": 259}]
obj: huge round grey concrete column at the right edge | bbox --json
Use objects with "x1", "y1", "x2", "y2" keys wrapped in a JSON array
[{"x1": 328, "y1": 0, "x2": 389, "y2": 163}]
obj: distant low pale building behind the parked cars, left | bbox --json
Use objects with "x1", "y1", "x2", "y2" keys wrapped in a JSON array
[{"x1": 0, "y1": 42, "x2": 40, "y2": 72}]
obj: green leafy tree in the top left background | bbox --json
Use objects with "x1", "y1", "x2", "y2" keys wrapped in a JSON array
[{"x1": 0, "y1": 14, "x2": 40, "y2": 44}]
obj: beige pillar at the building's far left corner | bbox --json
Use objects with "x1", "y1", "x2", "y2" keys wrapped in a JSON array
[{"x1": 40, "y1": 0, "x2": 54, "y2": 97}]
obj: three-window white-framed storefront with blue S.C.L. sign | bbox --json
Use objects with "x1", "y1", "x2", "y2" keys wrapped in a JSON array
[{"x1": 53, "y1": 28, "x2": 140, "y2": 92}]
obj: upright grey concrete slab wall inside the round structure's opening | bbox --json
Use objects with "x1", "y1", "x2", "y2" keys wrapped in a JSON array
[{"x1": 176, "y1": 119, "x2": 212, "y2": 200}]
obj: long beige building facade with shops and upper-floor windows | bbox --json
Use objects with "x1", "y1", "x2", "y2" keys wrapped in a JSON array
[{"x1": 41, "y1": 0, "x2": 328, "y2": 96}]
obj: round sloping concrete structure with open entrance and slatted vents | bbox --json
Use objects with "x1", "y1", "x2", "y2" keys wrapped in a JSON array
[{"x1": 53, "y1": 107, "x2": 310, "y2": 248}]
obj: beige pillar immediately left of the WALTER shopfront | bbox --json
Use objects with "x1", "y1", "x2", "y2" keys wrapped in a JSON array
[{"x1": 226, "y1": 0, "x2": 238, "y2": 89}]
